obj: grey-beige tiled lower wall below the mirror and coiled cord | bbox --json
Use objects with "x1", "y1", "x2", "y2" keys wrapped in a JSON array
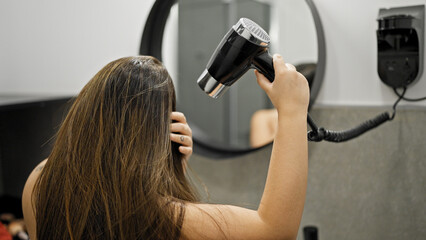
[{"x1": 190, "y1": 107, "x2": 426, "y2": 240}]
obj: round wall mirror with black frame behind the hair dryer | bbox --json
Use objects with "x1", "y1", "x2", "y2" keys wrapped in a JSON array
[{"x1": 140, "y1": 0, "x2": 325, "y2": 158}]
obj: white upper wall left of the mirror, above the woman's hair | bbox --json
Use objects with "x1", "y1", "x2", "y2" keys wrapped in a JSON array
[{"x1": 0, "y1": 0, "x2": 154, "y2": 95}]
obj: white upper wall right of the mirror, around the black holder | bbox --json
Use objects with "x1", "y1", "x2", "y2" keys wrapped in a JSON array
[{"x1": 314, "y1": 0, "x2": 426, "y2": 106}]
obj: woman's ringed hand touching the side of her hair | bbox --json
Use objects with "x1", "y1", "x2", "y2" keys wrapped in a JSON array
[{"x1": 170, "y1": 112, "x2": 193, "y2": 161}]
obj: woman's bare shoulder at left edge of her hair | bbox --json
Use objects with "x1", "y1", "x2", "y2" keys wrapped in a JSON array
[{"x1": 22, "y1": 159, "x2": 47, "y2": 239}]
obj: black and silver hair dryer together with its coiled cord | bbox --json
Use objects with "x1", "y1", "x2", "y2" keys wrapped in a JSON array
[{"x1": 197, "y1": 18, "x2": 395, "y2": 142}]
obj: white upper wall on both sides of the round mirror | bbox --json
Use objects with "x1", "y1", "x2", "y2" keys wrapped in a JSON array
[{"x1": 0, "y1": 0, "x2": 426, "y2": 106}]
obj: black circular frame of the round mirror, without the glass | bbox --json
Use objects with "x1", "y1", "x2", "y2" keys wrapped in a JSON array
[{"x1": 139, "y1": 0, "x2": 326, "y2": 159}]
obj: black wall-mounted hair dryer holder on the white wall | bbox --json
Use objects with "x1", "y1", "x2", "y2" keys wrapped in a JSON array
[{"x1": 377, "y1": 5, "x2": 425, "y2": 88}]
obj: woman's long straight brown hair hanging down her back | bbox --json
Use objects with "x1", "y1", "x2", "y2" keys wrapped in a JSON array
[{"x1": 33, "y1": 56, "x2": 196, "y2": 240}]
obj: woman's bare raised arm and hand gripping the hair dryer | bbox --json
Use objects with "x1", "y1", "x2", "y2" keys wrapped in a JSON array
[{"x1": 182, "y1": 55, "x2": 309, "y2": 239}]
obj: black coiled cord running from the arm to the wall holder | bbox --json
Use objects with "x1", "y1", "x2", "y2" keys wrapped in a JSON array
[{"x1": 308, "y1": 87, "x2": 407, "y2": 142}]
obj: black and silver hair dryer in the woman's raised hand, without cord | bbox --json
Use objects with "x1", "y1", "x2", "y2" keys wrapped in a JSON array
[{"x1": 197, "y1": 18, "x2": 275, "y2": 98}]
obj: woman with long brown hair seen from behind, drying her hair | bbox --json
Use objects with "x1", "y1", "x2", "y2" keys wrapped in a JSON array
[{"x1": 23, "y1": 56, "x2": 309, "y2": 240}]
